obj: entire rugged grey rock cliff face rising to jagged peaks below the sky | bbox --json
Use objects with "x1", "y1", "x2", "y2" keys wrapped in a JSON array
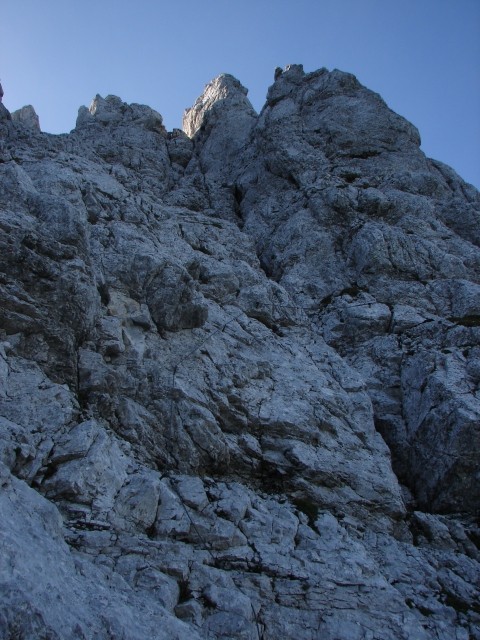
[{"x1": 0, "y1": 65, "x2": 480, "y2": 640}]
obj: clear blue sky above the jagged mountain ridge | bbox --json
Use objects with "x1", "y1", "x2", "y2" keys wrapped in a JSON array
[{"x1": 0, "y1": 0, "x2": 480, "y2": 187}]
